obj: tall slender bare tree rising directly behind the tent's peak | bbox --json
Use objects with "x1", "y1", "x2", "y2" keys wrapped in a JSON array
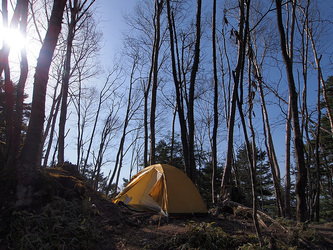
[{"x1": 125, "y1": 0, "x2": 165, "y2": 166}]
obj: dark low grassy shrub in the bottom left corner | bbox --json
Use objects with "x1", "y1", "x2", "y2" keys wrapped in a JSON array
[{"x1": 6, "y1": 198, "x2": 100, "y2": 249}]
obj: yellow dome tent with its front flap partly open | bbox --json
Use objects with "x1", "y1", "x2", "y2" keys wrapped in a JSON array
[{"x1": 114, "y1": 164, "x2": 207, "y2": 214}]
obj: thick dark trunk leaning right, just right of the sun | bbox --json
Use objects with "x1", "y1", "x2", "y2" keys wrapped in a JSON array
[{"x1": 16, "y1": 0, "x2": 66, "y2": 206}]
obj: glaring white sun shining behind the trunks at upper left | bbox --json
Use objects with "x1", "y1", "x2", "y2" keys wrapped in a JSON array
[{"x1": 0, "y1": 27, "x2": 26, "y2": 53}]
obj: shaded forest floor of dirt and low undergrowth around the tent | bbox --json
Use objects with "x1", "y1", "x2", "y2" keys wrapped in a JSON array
[{"x1": 0, "y1": 167, "x2": 333, "y2": 250}]
